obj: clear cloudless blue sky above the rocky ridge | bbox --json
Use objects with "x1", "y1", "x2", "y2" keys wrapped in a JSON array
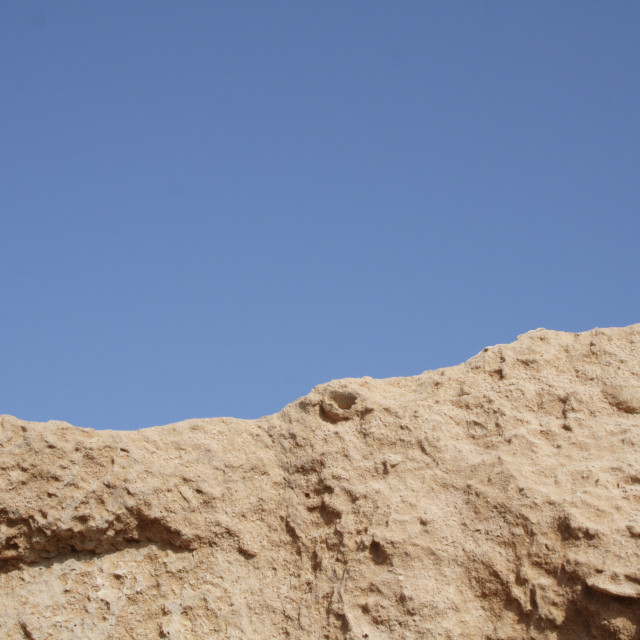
[{"x1": 0, "y1": 0, "x2": 640, "y2": 429}]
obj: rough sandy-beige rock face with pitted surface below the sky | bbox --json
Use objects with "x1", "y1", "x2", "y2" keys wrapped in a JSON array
[{"x1": 0, "y1": 325, "x2": 640, "y2": 640}]
